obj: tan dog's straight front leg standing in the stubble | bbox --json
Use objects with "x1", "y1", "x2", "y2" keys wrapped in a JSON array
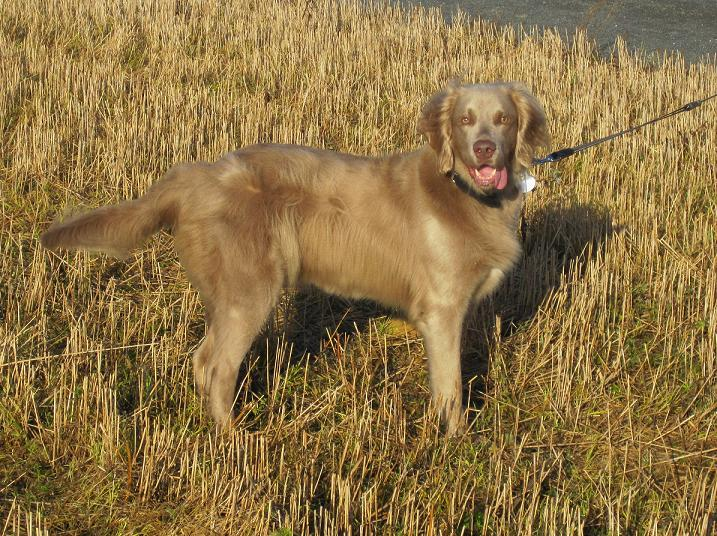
[{"x1": 417, "y1": 309, "x2": 464, "y2": 436}]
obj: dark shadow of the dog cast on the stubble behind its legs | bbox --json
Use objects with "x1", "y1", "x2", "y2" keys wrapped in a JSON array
[{"x1": 238, "y1": 199, "x2": 619, "y2": 416}]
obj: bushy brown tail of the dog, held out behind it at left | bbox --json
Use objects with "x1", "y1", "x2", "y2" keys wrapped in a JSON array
[{"x1": 40, "y1": 165, "x2": 186, "y2": 258}]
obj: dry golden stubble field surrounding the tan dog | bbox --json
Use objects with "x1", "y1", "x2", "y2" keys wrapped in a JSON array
[{"x1": 0, "y1": 0, "x2": 717, "y2": 535}]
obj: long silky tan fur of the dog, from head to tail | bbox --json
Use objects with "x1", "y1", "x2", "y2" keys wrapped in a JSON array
[{"x1": 41, "y1": 84, "x2": 548, "y2": 433}]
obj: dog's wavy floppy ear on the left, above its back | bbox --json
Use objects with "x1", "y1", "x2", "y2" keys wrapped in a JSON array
[{"x1": 418, "y1": 81, "x2": 459, "y2": 173}]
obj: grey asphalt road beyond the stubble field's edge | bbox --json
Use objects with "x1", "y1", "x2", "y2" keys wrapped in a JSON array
[{"x1": 404, "y1": 0, "x2": 717, "y2": 63}]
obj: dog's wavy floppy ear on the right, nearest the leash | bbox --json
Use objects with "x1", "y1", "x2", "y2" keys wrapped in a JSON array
[{"x1": 510, "y1": 84, "x2": 550, "y2": 167}]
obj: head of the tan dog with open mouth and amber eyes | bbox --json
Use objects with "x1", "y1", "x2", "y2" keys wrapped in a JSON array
[{"x1": 418, "y1": 83, "x2": 549, "y2": 193}]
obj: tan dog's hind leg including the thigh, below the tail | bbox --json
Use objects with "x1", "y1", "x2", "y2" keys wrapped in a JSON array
[{"x1": 175, "y1": 220, "x2": 285, "y2": 427}]
